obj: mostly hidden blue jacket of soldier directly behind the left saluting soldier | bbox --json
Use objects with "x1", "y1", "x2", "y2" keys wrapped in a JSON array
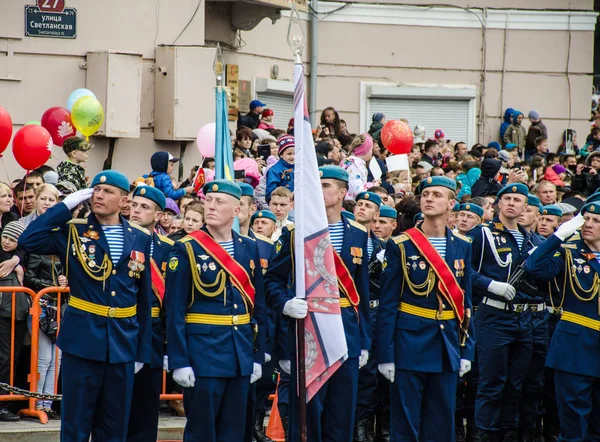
[{"x1": 150, "y1": 233, "x2": 174, "y2": 368}]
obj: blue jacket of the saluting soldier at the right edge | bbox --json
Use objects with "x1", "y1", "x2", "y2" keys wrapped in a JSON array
[{"x1": 527, "y1": 235, "x2": 600, "y2": 378}]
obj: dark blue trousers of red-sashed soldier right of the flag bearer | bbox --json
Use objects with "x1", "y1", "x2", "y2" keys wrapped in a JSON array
[{"x1": 390, "y1": 370, "x2": 458, "y2": 442}]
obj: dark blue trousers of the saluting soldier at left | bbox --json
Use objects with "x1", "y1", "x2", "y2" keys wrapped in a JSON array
[{"x1": 60, "y1": 352, "x2": 134, "y2": 442}]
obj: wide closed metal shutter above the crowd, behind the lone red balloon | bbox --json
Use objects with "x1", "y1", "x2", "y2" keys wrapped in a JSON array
[{"x1": 367, "y1": 97, "x2": 469, "y2": 143}]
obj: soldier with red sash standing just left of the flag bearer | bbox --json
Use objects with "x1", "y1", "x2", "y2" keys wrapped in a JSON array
[{"x1": 165, "y1": 180, "x2": 266, "y2": 442}]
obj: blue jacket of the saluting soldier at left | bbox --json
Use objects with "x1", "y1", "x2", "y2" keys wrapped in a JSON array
[{"x1": 19, "y1": 203, "x2": 154, "y2": 363}]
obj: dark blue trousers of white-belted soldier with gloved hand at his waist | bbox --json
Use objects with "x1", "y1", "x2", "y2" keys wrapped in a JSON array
[{"x1": 475, "y1": 304, "x2": 533, "y2": 432}]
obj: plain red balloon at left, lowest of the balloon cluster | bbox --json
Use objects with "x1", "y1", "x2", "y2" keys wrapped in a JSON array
[{"x1": 13, "y1": 124, "x2": 52, "y2": 170}]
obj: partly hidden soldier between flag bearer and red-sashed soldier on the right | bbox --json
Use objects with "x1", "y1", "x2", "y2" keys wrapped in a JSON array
[{"x1": 354, "y1": 192, "x2": 389, "y2": 442}]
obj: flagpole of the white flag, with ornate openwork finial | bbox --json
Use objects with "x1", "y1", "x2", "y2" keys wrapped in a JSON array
[{"x1": 287, "y1": 5, "x2": 307, "y2": 442}]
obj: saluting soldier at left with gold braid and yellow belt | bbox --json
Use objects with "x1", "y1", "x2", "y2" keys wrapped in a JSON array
[{"x1": 19, "y1": 170, "x2": 154, "y2": 441}]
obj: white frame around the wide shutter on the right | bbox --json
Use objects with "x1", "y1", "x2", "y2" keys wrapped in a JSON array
[{"x1": 359, "y1": 81, "x2": 477, "y2": 146}]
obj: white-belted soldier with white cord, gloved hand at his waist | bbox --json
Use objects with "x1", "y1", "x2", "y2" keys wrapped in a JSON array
[{"x1": 469, "y1": 184, "x2": 533, "y2": 441}]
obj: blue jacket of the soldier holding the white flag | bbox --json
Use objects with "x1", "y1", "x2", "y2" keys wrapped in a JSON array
[{"x1": 265, "y1": 216, "x2": 371, "y2": 359}]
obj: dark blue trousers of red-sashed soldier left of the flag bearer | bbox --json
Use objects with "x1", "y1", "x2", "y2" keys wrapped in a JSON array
[{"x1": 183, "y1": 376, "x2": 250, "y2": 442}]
